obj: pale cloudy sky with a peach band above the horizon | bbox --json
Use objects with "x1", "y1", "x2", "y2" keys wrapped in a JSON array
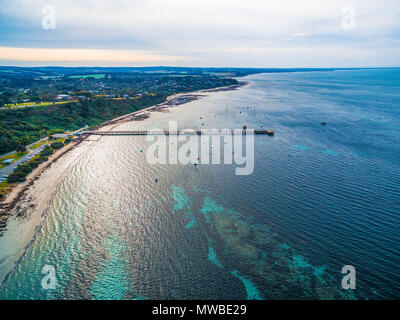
[{"x1": 0, "y1": 0, "x2": 400, "y2": 68}]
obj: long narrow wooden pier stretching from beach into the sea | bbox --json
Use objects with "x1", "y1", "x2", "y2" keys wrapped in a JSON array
[{"x1": 81, "y1": 129, "x2": 275, "y2": 136}]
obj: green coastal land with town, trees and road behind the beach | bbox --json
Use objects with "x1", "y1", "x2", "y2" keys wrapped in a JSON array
[{"x1": 0, "y1": 67, "x2": 248, "y2": 201}]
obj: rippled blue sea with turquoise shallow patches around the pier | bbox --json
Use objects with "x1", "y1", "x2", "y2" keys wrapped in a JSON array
[{"x1": 0, "y1": 70, "x2": 400, "y2": 299}]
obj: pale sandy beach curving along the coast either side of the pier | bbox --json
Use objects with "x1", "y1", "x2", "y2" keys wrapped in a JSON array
[{"x1": 0, "y1": 78, "x2": 246, "y2": 290}]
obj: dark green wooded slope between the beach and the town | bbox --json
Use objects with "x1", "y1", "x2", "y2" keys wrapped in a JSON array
[{"x1": 0, "y1": 96, "x2": 165, "y2": 154}]
